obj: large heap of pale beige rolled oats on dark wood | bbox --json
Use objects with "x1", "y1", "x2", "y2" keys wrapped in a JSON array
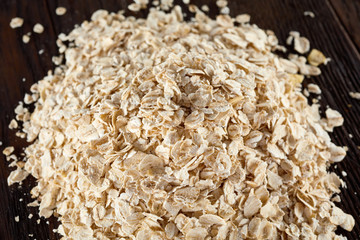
[{"x1": 9, "y1": 6, "x2": 354, "y2": 239}]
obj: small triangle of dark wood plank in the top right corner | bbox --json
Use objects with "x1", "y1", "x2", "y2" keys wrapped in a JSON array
[{"x1": 330, "y1": 0, "x2": 360, "y2": 51}]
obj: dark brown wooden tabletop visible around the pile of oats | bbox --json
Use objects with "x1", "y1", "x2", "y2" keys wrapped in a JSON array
[{"x1": 0, "y1": 0, "x2": 360, "y2": 240}]
